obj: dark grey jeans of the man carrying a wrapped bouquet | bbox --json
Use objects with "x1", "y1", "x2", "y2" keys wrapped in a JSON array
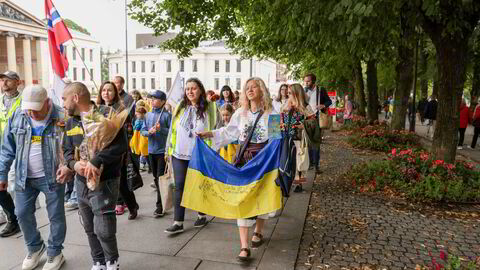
[{"x1": 75, "y1": 178, "x2": 120, "y2": 265}]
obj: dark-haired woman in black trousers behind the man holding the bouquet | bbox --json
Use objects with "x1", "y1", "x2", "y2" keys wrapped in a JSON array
[{"x1": 97, "y1": 81, "x2": 138, "y2": 220}]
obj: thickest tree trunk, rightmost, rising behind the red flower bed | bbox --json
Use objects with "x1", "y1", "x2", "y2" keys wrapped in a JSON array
[{"x1": 429, "y1": 30, "x2": 473, "y2": 163}]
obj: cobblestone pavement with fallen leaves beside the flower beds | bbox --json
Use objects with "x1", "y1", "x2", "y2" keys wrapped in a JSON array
[{"x1": 296, "y1": 133, "x2": 480, "y2": 270}]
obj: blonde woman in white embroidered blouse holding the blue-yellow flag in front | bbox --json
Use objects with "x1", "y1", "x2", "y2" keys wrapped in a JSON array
[{"x1": 197, "y1": 77, "x2": 275, "y2": 261}]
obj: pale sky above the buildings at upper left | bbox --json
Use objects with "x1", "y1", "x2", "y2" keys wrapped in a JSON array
[{"x1": 10, "y1": 0, "x2": 153, "y2": 51}]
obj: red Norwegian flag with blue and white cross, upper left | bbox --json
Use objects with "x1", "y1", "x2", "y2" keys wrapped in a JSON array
[{"x1": 45, "y1": 0, "x2": 72, "y2": 79}]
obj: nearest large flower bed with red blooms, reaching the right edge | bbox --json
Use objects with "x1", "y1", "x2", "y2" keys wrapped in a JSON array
[{"x1": 348, "y1": 148, "x2": 480, "y2": 202}]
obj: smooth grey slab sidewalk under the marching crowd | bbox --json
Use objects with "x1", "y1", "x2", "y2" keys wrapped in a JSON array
[{"x1": 0, "y1": 170, "x2": 313, "y2": 270}]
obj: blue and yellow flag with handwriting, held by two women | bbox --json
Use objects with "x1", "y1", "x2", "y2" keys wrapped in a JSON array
[{"x1": 182, "y1": 138, "x2": 282, "y2": 219}]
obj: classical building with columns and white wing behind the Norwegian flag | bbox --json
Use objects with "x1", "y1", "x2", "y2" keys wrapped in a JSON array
[{"x1": 0, "y1": 0, "x2": 101, "y2": 90}]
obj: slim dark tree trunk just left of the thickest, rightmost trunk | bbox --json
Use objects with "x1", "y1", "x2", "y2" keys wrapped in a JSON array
[{"x1": 391, "y1": 11, "x2": 414, "y2": 130}]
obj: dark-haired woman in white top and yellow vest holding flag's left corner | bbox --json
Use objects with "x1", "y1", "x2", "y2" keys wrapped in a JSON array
[{"x1": 165, "y1": 78, "x2": 217, "y2": 234}]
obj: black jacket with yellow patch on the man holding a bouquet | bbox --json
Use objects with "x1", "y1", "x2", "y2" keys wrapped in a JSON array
[{"x1": 63, "y1": 107, "x2": 128, "y2": 181}]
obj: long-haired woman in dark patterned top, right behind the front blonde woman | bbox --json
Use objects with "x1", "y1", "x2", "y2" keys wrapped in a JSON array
[{"x1": 281, "y1": 83, "x2": 314, "y2": 192}]
